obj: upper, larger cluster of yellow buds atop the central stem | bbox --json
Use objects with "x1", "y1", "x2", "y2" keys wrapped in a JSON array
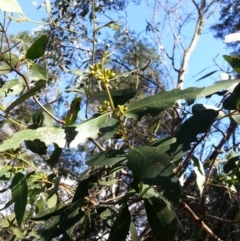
[{"x1": 89, "y1": 63, "x2": 116, "y2": 83}]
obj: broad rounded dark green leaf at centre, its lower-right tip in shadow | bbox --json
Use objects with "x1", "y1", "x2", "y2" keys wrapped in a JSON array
[{"x1": 128, "y1": 146, "x2": 180, "y2": 203}]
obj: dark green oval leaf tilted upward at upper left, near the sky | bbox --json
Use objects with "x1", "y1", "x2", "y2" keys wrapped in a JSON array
[{"x1": 26, "y1": 35, "x2": 48, "y2": 59}]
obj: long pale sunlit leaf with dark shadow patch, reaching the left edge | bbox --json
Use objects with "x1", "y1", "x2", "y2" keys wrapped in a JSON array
[{"x1": 0, "y1": 114, "x2": 108, "y2": 152}]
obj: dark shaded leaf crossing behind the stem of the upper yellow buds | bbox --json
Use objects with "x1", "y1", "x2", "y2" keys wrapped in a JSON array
[{"x1": 92, "y1": 89, "x2": 137, "y2": 107}]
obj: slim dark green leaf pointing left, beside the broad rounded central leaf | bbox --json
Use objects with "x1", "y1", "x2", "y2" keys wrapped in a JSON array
[{"x1": 86, "y1": 149, "x2": 127, "y2": 166}]
